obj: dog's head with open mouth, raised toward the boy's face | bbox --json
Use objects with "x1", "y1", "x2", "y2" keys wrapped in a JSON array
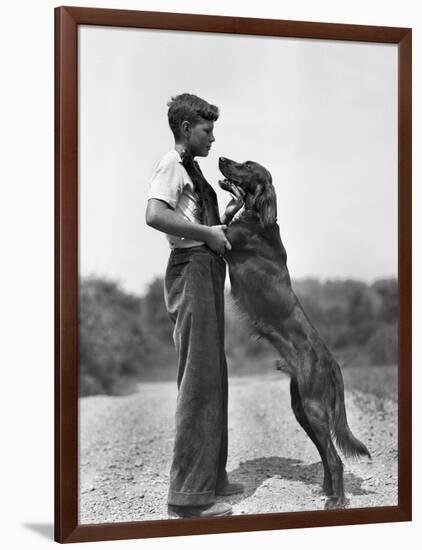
[{"x1": 218, "y1": 157, "x2": 277, "y2": 227}]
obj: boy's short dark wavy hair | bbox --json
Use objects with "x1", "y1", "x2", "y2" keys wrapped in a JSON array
[{"x1": 167, "y1": 94, "x2": 220, "y2": 139}]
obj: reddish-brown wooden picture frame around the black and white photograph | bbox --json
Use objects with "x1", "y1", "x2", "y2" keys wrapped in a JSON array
[{"x1": 55, "y1": 7, "x2": 412, "y2": 543}]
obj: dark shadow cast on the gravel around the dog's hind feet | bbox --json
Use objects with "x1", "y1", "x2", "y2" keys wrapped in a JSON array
[{"x1": 223, "y1": 456, "x2": 374, "y2": 504}]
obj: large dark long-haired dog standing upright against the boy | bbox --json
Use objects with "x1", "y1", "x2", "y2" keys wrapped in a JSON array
[{"x1": 219, "y1": 157, "x2": 370, "y2": 508}]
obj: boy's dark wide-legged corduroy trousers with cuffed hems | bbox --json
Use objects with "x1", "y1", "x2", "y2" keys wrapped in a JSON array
[{"x1": 164, "y1": 246, "x2": 228, "y2": 506}]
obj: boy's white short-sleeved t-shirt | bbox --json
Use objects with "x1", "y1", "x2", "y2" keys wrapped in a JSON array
[{"x1": 148, "y1": 149, "x2": 204, "y2": 248}]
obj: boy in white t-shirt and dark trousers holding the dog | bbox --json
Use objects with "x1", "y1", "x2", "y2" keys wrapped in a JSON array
[{"x1": 146, "y1": 94, "x2": 243, "y2": 517}]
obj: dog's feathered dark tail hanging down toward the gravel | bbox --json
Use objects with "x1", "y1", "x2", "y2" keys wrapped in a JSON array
[{"x1": 331, "y1": 360, "x2": 371, "y2": 458}]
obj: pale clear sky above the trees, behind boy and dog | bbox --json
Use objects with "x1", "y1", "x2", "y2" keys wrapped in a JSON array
[{"x1": 78, "y1": 25, "x2": 398, "y2": 294}]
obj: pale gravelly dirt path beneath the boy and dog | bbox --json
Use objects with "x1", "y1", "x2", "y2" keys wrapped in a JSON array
[{"x1": 79, "y1": 374, "x2": 397, "y2": 523}]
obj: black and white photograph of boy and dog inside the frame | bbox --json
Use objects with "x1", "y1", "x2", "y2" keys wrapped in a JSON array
[{"x1": 78, "y1": 25, "x2": 398, "y2": 524}]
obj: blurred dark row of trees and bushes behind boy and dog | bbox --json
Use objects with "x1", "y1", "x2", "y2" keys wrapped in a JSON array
[{"x1": 79, "y1": 277, "x2": 397, "y2": 396}]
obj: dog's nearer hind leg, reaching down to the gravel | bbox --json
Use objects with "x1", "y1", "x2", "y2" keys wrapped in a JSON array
[{"x1": 302, "y1": 398, "x2": 347, "y2": 509}]
